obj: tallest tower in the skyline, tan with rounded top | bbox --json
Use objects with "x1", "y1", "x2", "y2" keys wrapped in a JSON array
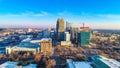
[{"x1": 56, "y1": 18, "x2": 65, "y2": 41}]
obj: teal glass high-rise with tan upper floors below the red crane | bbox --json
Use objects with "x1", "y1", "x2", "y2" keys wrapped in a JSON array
[{"x1": 78, "y1": 27, "x2": 90, "y2": 46}]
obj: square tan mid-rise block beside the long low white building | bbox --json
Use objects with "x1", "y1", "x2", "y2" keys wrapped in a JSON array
[{"x1": 40, "y1": 38, "x2": 52, "y2": 54}]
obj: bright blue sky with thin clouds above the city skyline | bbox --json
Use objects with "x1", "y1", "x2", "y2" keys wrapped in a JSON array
[{"x1": 0, "y1": 0, "x2": 120, "y2": 29}]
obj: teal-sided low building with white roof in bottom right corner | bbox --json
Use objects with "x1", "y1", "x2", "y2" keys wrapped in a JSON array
[{"x1": 92, "y1": 55, "x2": 120, "y2": 68}]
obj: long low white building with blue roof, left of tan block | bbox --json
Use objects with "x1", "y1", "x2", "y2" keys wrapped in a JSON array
[{"x1": 6, "y1": 38, "x2": 40, "y2": 54}]
